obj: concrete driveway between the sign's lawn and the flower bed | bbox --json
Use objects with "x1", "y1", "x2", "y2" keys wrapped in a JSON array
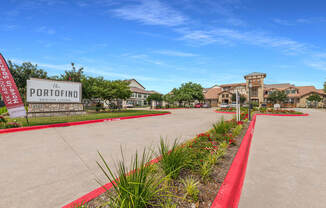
[{"x1": 0, "y1": 109, "x2": 230, "y2": 208}]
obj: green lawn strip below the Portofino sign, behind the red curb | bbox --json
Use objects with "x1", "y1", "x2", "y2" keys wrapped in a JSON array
[{"x1": 8, "y1": 110, "x2": 167, "y2": 126}]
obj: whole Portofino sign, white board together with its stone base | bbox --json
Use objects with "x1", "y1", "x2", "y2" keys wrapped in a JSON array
[{"x1": 26, "y1": 78, "x2": 85, "y2": 117}]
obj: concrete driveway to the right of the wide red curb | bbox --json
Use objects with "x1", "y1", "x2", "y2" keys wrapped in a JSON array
[{"x1": 239, "y1": 110, "x2": 326, "y2": 208}]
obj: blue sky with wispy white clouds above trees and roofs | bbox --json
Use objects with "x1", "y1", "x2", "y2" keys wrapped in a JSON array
[{"x1": 0, "y1": 0, "x2": 326, "y2": 93}]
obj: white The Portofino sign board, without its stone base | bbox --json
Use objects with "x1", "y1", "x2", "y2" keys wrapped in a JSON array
[{"x1": 26, "y1": 79, "x2": 82, "y2": 103}]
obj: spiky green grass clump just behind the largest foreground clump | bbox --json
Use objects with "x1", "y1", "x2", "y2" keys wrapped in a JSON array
[{"x1": 159, "y1": 138, "x2": 187, "y2": 179}]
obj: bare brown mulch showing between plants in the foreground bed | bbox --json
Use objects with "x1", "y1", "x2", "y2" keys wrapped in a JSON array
[{"x1": 83, "y1": 123, "x2": 249, "y2": 208}]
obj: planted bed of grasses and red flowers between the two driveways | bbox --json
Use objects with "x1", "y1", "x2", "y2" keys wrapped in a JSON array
[{"x1": 71, "y1": 117, "x2": 248, "y2": 208}]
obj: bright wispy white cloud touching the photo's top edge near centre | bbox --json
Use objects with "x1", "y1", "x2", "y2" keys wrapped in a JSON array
[{"x1": 112, "y1": 0, "x2": 187, "y2": 26}]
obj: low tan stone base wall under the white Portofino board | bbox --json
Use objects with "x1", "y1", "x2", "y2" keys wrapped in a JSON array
[{"x1": 28, "y1": 103, "x2": 86, "y2": 117}]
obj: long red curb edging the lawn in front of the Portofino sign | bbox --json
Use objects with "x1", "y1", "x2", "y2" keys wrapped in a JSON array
[{"x1": 0, "y1": 112, "x2": 171, "y2": 134}]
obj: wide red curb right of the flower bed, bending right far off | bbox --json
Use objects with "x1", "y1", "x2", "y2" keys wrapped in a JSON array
[{"x1": 211, "y1": 114, "x2": 309, "y2": 208}]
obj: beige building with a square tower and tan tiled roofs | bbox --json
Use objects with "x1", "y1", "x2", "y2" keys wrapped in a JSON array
[{"x1": 204, "y1": 72, "x2": 326, "y2": 107}]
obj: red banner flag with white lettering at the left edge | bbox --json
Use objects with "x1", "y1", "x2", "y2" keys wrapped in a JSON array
[{"x1": 0, "y1": 53, "x2": 26, "y2": 118}]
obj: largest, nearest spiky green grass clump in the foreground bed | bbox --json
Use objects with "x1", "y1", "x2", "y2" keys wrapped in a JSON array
[{"x1": 97, "y1": 150, "x2": 164, "y2": 208}]
